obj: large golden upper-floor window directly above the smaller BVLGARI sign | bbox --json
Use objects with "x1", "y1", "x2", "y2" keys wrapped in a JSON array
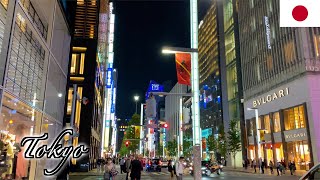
[{"x1": 284, "y1": 106, "x2": 305, "y2": 130}]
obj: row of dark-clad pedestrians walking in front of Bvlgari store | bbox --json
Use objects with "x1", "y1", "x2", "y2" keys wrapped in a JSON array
[{"x1": 242, "y1": 158, "x2": 296, "y2": 176}]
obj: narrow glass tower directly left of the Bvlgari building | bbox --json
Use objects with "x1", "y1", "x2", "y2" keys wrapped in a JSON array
[{"x1": 218, "y1": 0, "x2": 247, "y2": 166}]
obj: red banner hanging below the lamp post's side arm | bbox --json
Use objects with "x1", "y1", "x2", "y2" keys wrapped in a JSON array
[{"x1": 176, "y1": 53, "x2": 191, "y2": 86}]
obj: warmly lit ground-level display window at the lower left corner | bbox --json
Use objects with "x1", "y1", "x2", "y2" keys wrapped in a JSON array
[{"x1": 0, "y1": 93, "x2": 41, "y2": 179}]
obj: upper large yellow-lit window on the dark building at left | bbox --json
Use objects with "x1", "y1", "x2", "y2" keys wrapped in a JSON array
[{"x1": 70, "y1": 53, "x2": 85, "y2": 75}]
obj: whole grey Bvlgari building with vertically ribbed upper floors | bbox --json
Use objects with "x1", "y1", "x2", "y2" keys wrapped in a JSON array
[{"x1": 237, "y1": 0, "x2": 320, "y2": 170}]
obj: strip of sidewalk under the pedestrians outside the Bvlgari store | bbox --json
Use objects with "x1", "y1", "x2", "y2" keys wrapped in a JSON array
[{"x1": 223, "y1": 166, "x2": 307, "y2": 177}]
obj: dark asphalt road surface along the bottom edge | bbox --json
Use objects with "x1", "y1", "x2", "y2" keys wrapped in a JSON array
[{"x1": 70, "y1": 170, "x2": 299, "y2": 180}]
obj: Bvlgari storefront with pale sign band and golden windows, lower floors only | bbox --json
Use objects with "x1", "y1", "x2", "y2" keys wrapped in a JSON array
[{"x1": 244, "y1": 77, "x2": 320, "y2": 170}]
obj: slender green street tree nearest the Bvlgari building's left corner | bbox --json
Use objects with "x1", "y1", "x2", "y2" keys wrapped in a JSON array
[{"x1": 228, "y1": 120, "x2": 241, "y2": 168}]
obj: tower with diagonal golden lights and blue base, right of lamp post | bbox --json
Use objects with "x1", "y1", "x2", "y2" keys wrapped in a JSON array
[{"x1": 199, "y1": 1, "x2": 222, "y2": 130}]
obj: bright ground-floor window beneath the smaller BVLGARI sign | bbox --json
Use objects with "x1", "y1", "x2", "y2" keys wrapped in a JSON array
[{"x1": 287, "y1": 141, "x2": 311, "y2": 170}]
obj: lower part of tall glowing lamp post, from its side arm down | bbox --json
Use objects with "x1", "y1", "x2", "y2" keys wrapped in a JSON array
[{"x1": 162, "y1": 46, "x2": 201, "y2": 179}]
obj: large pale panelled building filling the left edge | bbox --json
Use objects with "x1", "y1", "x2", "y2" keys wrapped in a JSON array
[{"x1": 0, "y1": 0, "x2": 72, "y2": 179}]
